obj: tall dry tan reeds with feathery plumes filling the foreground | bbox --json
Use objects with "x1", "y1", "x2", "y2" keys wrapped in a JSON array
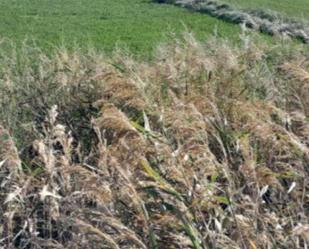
[{"x1": 0, "y1": 34, "x2": 309, "y2": 249}]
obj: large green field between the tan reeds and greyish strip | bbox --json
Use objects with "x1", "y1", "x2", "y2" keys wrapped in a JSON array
[{"x1": 0, "y1": 0, "x2": 240, "y2": 55}]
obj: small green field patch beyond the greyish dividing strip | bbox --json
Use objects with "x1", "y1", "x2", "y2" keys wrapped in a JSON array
[{"x1": 224, "y1": 0, "x2": 309, "y2": 19}]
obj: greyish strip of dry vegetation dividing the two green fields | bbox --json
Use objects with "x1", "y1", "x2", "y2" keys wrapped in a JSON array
[{"x1": 155, "y1": 0, "x2": 309, "y2": 44}]
